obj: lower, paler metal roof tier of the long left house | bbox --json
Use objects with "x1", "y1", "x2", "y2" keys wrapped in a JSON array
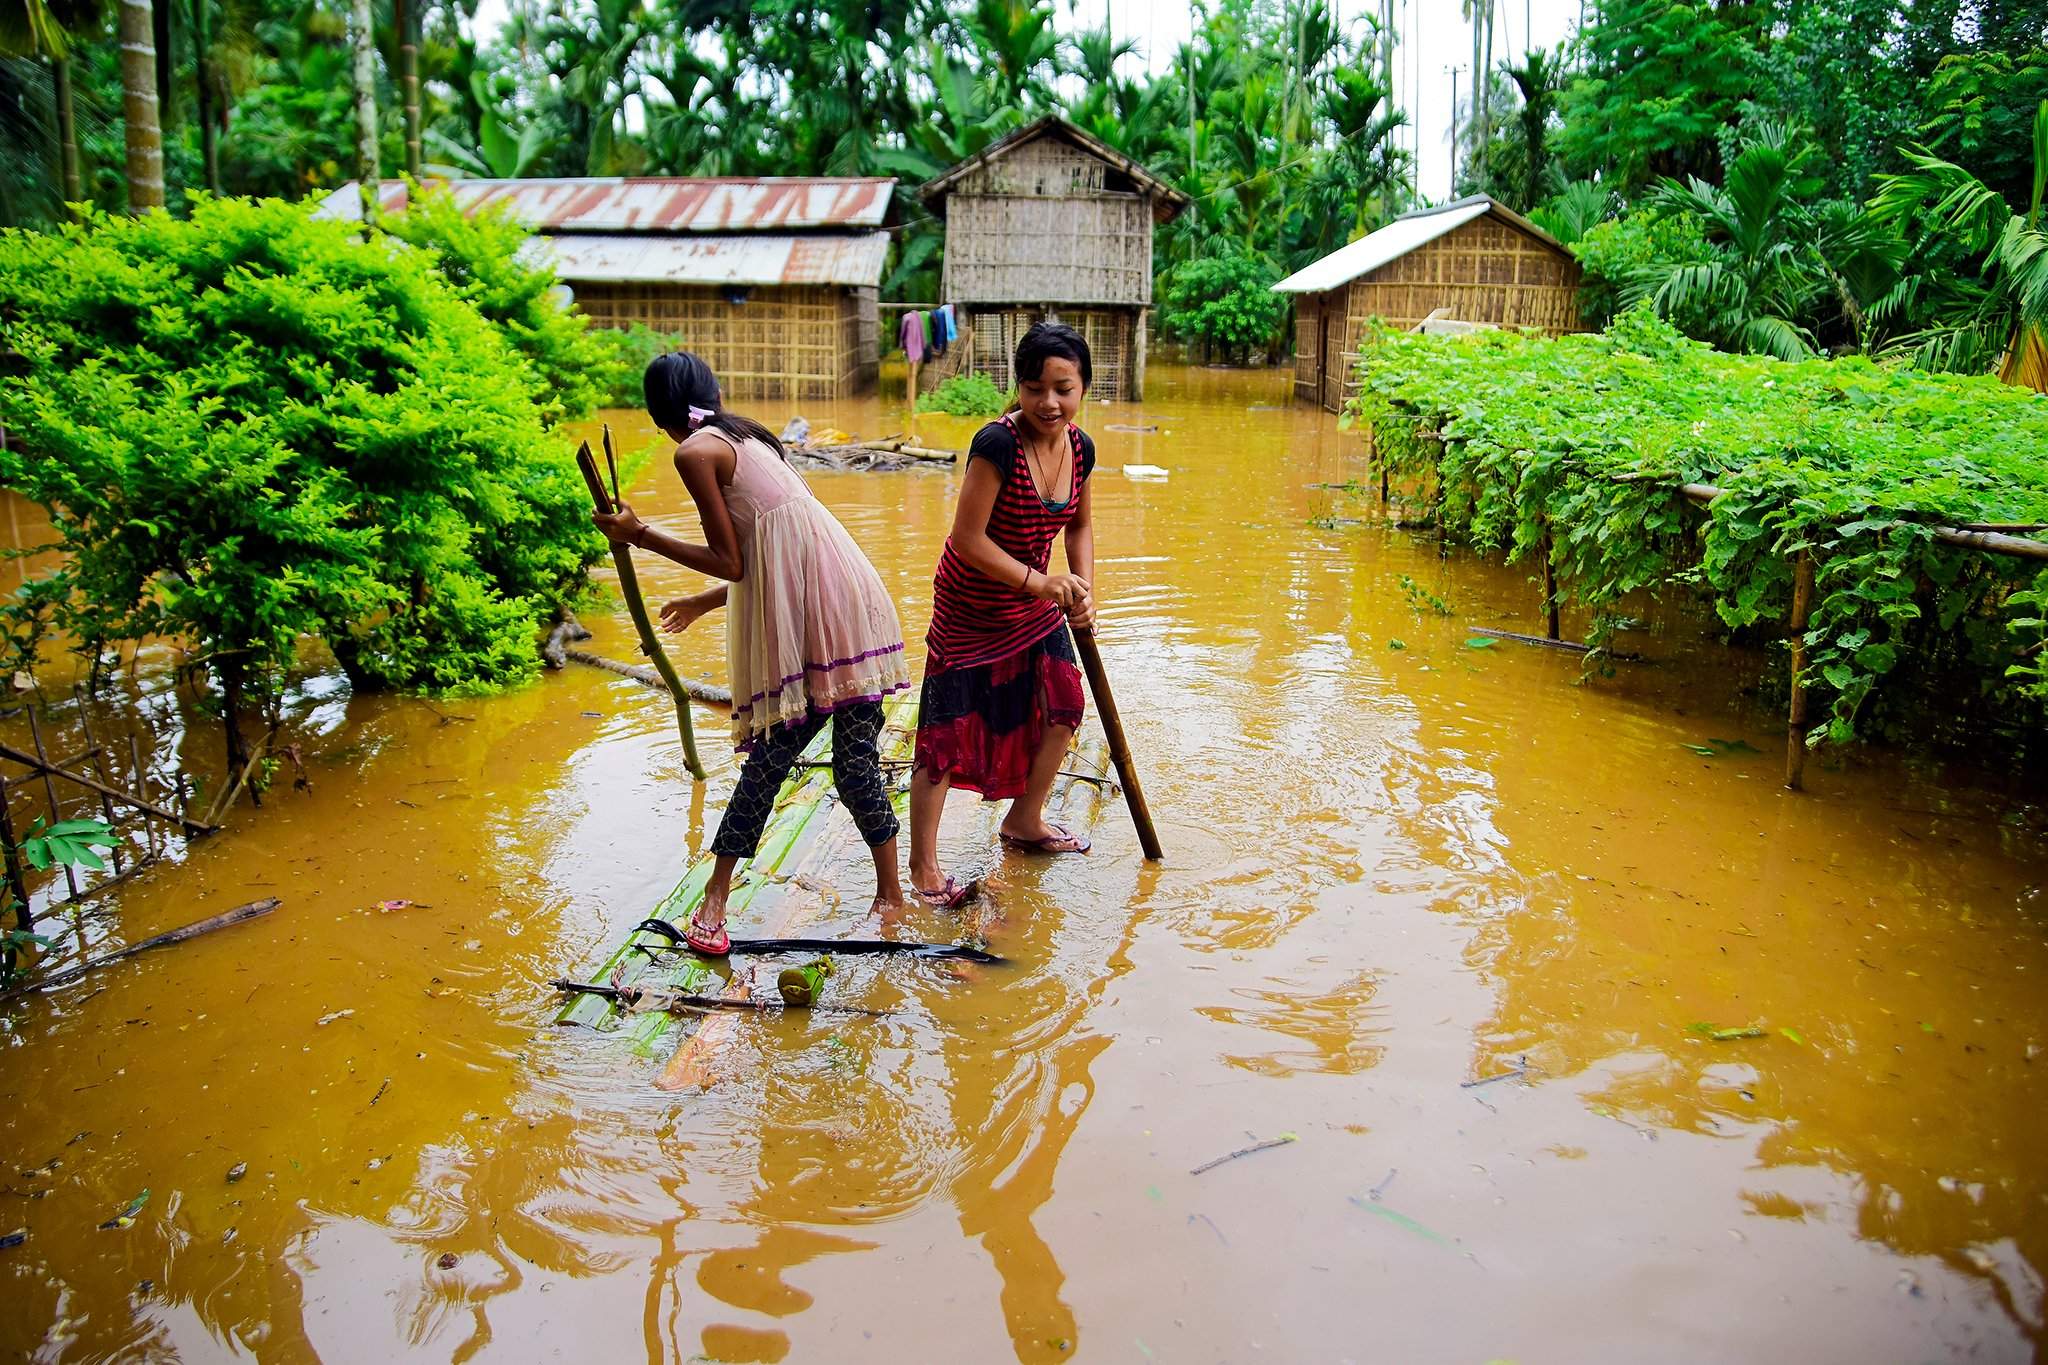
[{"x1": 520, "y1": 231, "x2": 889, "y2": 289}]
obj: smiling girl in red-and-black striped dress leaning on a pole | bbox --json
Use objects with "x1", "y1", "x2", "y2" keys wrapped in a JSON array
[{"x1": 909, "y1": 323, "x2": 1096, "y2": 909}]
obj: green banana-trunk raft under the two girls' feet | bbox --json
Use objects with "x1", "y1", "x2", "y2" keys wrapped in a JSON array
[{"x1": 555, "y1": 696, "x2": 1116, "y2": 1089}]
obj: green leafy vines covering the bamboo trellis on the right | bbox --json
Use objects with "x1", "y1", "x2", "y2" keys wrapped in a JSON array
[{"x1": 1354, "y1": 309, "x2": 2048, "y2": 741}]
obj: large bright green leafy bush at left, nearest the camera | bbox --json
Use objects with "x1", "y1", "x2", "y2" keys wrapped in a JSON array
[{"x1": 0, "y1": 201, "x2": 600, "y2": 720}]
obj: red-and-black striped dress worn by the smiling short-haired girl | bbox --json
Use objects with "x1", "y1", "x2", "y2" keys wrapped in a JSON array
[{"x1": 918, "y1": 417, "x2": 1096, "y2": 800}]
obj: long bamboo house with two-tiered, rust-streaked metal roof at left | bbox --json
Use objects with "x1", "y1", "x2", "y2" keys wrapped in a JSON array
[{"x1": 319, "y1": 176, "x2": 895, "y2": 401}]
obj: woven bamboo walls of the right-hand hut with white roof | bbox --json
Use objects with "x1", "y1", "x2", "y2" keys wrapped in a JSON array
[{"x1": 1294, "y1": 217, "x2": 1585, "y2": 411}]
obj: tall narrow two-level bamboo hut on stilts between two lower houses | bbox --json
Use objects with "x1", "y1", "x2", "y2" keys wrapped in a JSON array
[{"x1": 920, "y1": 117, "x2": 1188, "y2": 399}]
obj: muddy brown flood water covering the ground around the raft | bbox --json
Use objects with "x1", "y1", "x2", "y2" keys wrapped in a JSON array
[{"x1": 0, "y1": 370, "x2": 2048, "y2": 1365}]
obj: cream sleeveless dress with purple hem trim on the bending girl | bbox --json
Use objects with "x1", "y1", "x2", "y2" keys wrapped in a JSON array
[{"x1": 711, "y1": 428, "x2": 909, "y2": 749}]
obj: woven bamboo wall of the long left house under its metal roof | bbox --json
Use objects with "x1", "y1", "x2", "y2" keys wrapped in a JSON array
[{"x1": 575, "y1": 284, "x2": 881, "y2": 401}]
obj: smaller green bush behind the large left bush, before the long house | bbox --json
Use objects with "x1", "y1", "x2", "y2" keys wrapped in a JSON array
[{"x1": 381, "y1": 188, "x2": 610, "y2": 420}]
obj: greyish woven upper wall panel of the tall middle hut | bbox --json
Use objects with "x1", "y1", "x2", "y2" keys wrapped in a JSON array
[{"x1": 944, "y1": 194, "x2": 1153, "y2": 307}]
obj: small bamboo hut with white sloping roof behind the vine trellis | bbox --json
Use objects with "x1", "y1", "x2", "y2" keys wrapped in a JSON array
[{"x1": 1274, "y1": 194, "x2": 1585, "y2": 411}]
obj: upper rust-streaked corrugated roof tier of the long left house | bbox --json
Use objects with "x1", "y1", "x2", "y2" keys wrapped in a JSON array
[{"x1": 315, "y1": 176, "x2": 895, "y2": 233}]
